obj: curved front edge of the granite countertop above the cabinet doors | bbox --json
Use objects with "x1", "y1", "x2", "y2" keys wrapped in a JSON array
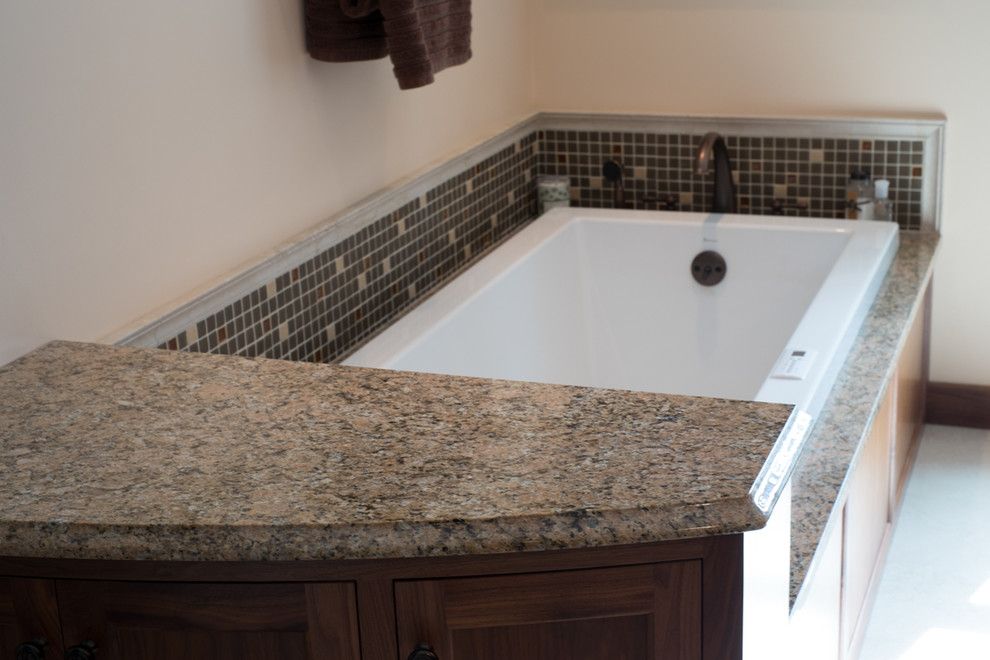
[{"x1": 0, "y1": 498, "x2": 767, "y2": 562}]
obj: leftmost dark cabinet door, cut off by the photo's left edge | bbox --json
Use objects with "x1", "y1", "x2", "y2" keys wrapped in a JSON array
[{"x1": 0, "y1": 578, "x2": 62, "y2": 660}]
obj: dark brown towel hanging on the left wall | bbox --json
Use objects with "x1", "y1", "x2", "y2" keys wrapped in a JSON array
[{"x1": 306, "y1": 0, "x2": 471, "y2": 89}]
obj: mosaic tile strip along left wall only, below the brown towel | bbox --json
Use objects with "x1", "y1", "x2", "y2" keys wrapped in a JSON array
[{"x1": 160, "y1": 134, "x2": 537, "y2": 362}]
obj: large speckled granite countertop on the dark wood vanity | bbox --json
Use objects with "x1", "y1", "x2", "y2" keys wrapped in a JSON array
[{"x1": 0, "y1": 342, "x2": 791, "y2": 560}]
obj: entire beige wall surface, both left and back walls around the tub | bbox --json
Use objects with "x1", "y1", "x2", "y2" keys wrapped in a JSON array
[{"x1": 0, "y1": 0, "x2": 990, "y2": 383}]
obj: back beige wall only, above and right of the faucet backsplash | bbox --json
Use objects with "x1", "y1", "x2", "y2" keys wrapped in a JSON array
[{"x1": 535, "y1": 0, "x2": 990, "y2": 384}]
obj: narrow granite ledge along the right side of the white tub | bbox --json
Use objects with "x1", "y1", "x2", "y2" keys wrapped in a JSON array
[{"x1": 791, "y1": 232, "x2": 938, "y2": 604}]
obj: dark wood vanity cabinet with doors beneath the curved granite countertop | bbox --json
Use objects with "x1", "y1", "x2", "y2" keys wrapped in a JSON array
[{"x1": 0, "y1": 535, "x2": 742, "y2": 660}]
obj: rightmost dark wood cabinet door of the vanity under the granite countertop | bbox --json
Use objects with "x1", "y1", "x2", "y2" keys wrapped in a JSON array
[{"x1": 395, "y1": 561, "x2": 702, "y2": 660}]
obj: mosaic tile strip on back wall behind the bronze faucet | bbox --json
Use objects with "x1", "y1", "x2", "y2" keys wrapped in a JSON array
[{"x1": 537, "y1": 130, "x2": 924, "y2": 230}]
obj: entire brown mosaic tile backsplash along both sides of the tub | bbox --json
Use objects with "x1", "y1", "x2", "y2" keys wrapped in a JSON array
[{"x1": 160, "y1": 121, "x2": 924, "y2": 362}]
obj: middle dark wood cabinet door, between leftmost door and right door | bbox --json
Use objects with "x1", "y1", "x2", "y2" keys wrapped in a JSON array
[{"x1": 58, "y1": 581, "x2": 359, "y2": 660}]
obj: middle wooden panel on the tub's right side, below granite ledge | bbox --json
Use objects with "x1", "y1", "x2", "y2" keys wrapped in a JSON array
[{"x1": 842, "y1": 389, "x2": 894, "y2": 649}]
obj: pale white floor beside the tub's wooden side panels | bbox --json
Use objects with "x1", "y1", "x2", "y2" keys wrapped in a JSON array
[{"x1": 860, "y1": 426, "x2": 990, "y2": 660}]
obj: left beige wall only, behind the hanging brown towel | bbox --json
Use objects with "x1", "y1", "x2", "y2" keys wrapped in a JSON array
[{"x1": 0, "y1": 0, "x2": 533, "y2": 364}]
